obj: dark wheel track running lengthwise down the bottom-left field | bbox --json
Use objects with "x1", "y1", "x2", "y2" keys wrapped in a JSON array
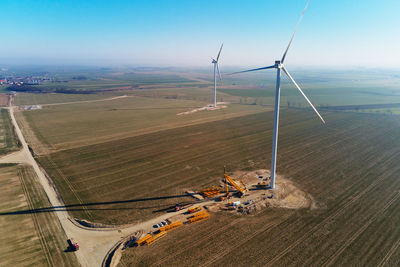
[{"x1": 18, "y1": 170, "x2": 56, "y2": 266}]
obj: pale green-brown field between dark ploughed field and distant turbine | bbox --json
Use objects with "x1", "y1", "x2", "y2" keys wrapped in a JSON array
[{"x1": 16, "y1": 97, "x2": 270, "y2": 151}]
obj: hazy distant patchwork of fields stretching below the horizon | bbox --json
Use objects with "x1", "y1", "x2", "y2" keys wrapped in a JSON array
[{"x1": 10, "y1": 68, "x2": 400, "y2": 107}]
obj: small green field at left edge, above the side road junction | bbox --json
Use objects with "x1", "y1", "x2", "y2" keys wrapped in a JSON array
[{"x1": 0, "y1": 109, "x2": 19, "y2": 154}]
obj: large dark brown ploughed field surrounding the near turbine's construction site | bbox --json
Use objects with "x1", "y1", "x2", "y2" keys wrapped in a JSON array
[{"x1": 21, "y1": 103, "x2": 400, "y2": 266}]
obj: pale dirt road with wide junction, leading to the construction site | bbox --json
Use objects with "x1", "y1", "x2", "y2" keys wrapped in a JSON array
[{"x1": 0, "y1": 107, "x2": 212, "y2": 266}]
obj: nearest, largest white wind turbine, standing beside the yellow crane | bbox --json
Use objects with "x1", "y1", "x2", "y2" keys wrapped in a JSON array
[{"x1": 229, "y1": 0, "x2": 325, "y2": 189}]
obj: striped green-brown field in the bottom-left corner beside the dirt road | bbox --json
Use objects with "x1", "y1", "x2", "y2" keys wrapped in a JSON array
[{"x1": 0, "y1": 165, "x2": 78, "y2": 266}]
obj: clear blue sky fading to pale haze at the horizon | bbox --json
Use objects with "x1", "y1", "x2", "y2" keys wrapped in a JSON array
[{"x1": 0, "y1": 0, "x2": 400, "y2": 68}]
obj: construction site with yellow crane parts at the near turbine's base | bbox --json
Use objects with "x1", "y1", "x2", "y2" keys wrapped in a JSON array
[{"x1": 120, "y1": 168, "x2": 317, "y2": 251}]
